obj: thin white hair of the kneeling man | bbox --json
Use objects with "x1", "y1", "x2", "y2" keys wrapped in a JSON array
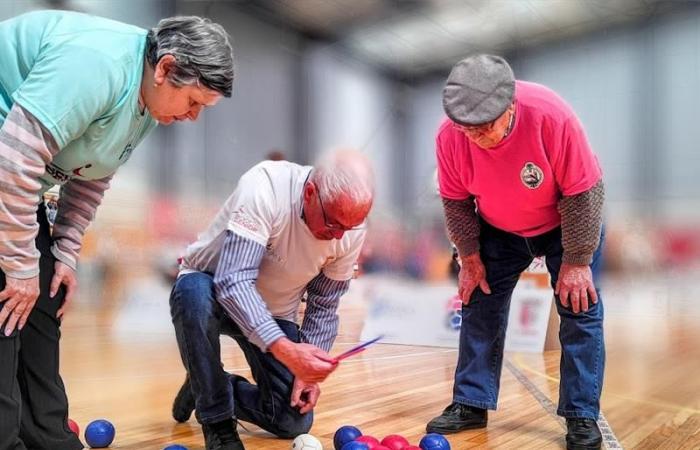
[{"x1": 311, "y1": 150, "x2": 375, "y2": 205}]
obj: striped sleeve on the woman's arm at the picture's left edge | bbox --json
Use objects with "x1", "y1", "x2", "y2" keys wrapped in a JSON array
[{"x1": 0, "y1": 103, "x2": 59, "y2": 278}]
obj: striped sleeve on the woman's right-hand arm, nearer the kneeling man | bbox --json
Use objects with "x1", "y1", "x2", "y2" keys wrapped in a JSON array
[{"x1": 51, "y1": 175, "x2": 112, "y2": 269}]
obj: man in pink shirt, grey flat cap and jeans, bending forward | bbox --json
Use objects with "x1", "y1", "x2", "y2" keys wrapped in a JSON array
[{"x1": 427, "y1": 55, "x2": 605, "y2": 449}]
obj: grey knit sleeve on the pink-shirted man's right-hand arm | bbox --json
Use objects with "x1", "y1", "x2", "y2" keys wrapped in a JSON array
[{"x1": 559, "y1": 180, "x2": 605, "y2": 265}]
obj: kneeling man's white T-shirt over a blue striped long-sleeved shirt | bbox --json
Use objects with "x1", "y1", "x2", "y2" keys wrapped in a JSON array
[{"x1": 180, "y1": 161, "x2": 365, "y2": 351}]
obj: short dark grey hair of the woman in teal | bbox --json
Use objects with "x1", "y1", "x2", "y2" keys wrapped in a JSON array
[{"x1": 146, "y1": 16, "x2": 233, "y2": 97}]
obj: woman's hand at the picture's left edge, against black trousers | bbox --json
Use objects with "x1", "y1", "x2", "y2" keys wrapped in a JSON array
[{"x1": 0, "y1": 275, "x2": 39, "y2": 336}]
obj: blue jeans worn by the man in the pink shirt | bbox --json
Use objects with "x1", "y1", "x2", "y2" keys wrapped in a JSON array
[{"x1": 453, "y1": 220, "x2": 605, "y2": 419}]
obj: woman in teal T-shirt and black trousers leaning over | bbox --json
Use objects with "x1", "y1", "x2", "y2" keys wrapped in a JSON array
[{"x1": 0, "y1": 11, "x2": 233, "y2": 450}]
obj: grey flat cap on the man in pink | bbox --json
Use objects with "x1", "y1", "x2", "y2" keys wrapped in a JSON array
[{"x1": 442, "y1": 55, "x2": 515, "y2": 126}]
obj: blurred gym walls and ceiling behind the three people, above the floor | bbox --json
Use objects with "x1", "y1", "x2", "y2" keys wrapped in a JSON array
[{"x1": 0, "y1": 0, "x2": 700, "y2": 280}]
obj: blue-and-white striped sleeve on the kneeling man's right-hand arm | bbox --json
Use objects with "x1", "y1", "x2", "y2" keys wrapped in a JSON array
[{"x1": 300, "y1": 273, "x2": 350, "y2": 352}]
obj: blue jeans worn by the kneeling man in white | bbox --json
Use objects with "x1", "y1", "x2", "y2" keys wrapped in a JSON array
[{"x1": 170, "y1": 272, "x2": 313, "y2": 438}]
